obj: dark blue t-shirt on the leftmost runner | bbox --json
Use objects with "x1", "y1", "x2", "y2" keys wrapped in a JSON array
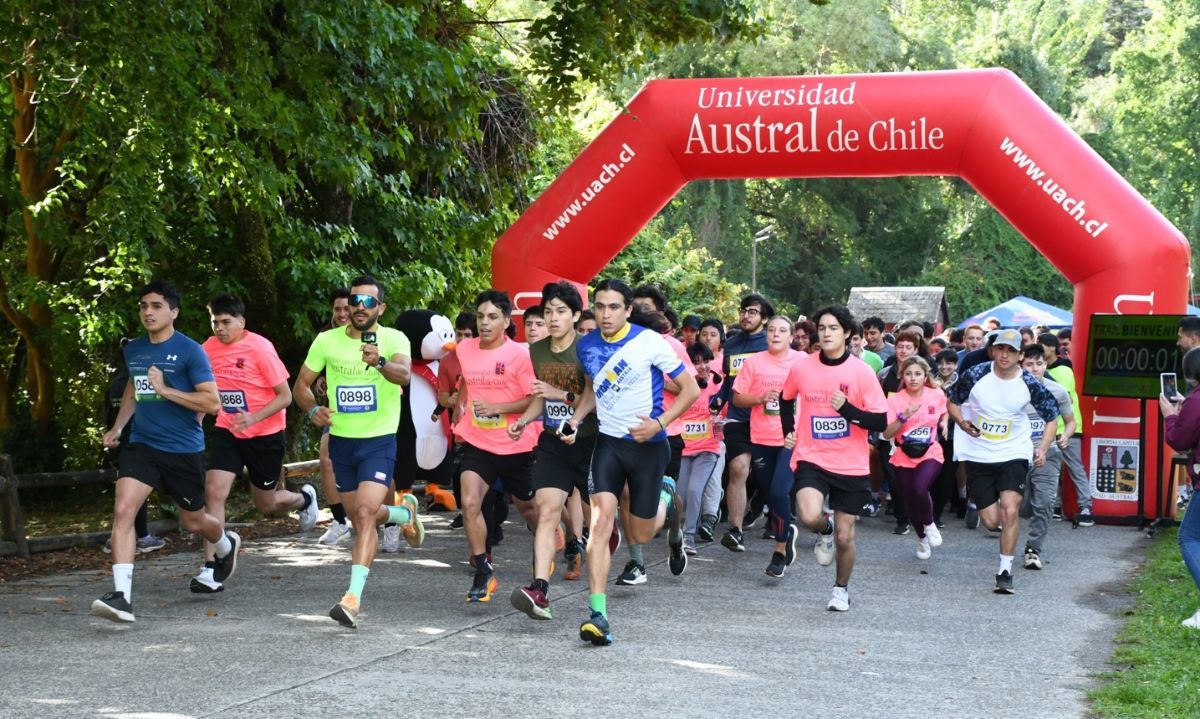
[{"x1": 125, "y1": 331, "x2": 215, "y2": 454}]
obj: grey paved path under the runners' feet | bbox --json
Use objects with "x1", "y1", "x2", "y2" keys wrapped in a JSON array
[{"x1": 0, "y1": 515, "x2": 1146, "y2": 719}]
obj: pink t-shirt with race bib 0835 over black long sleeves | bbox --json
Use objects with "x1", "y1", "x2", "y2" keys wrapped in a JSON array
[{"x1": 782, "y1": 352, "x2": 888, "y2": 477}]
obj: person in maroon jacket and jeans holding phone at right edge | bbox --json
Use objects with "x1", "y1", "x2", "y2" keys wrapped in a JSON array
[{"x1": 1158, "y1": 347, "x2": 1200, "y2": 629}]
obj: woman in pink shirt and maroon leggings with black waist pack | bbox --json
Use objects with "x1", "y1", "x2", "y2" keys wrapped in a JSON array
[{"x1": 883, "y1": 356, "x2": 947, "y2": 559}]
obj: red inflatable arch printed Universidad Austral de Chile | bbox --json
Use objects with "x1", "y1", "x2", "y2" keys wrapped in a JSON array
[{"x1": 492, "y1": 70, "x2": 1190, "y2": 520}]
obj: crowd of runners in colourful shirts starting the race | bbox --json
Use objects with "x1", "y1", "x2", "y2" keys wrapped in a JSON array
[{"x1": 92, "y1": 275, "x2": 1200, "y2": 646}]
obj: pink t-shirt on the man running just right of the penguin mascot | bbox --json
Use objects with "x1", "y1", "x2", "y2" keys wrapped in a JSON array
[{"x1": 454, "y1": 337, "x2": 538, "y2": 455}]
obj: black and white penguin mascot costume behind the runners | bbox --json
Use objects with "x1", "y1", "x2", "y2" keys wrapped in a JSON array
[{"x1": 396, "y1": 310, "x2": 457, "y2": 511}]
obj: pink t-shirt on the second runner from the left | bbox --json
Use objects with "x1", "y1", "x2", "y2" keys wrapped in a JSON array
[{"x1": 203, "y1": 331, "x2": 288, "y2": 439}]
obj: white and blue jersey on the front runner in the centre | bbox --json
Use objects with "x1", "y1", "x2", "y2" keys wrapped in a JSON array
[{"x1": 577, "y1": 324, "x2": 684, "y2": 442}]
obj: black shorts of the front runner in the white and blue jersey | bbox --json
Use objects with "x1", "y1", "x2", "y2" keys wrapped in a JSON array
[{"x1": 588, "y1": 435, "x2": 671, "y2": 520}]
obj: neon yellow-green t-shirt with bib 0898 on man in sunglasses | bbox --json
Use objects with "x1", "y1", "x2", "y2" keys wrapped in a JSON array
[{"x1": 304, "y1": 326, "x2": 410, "y2": 439}]
